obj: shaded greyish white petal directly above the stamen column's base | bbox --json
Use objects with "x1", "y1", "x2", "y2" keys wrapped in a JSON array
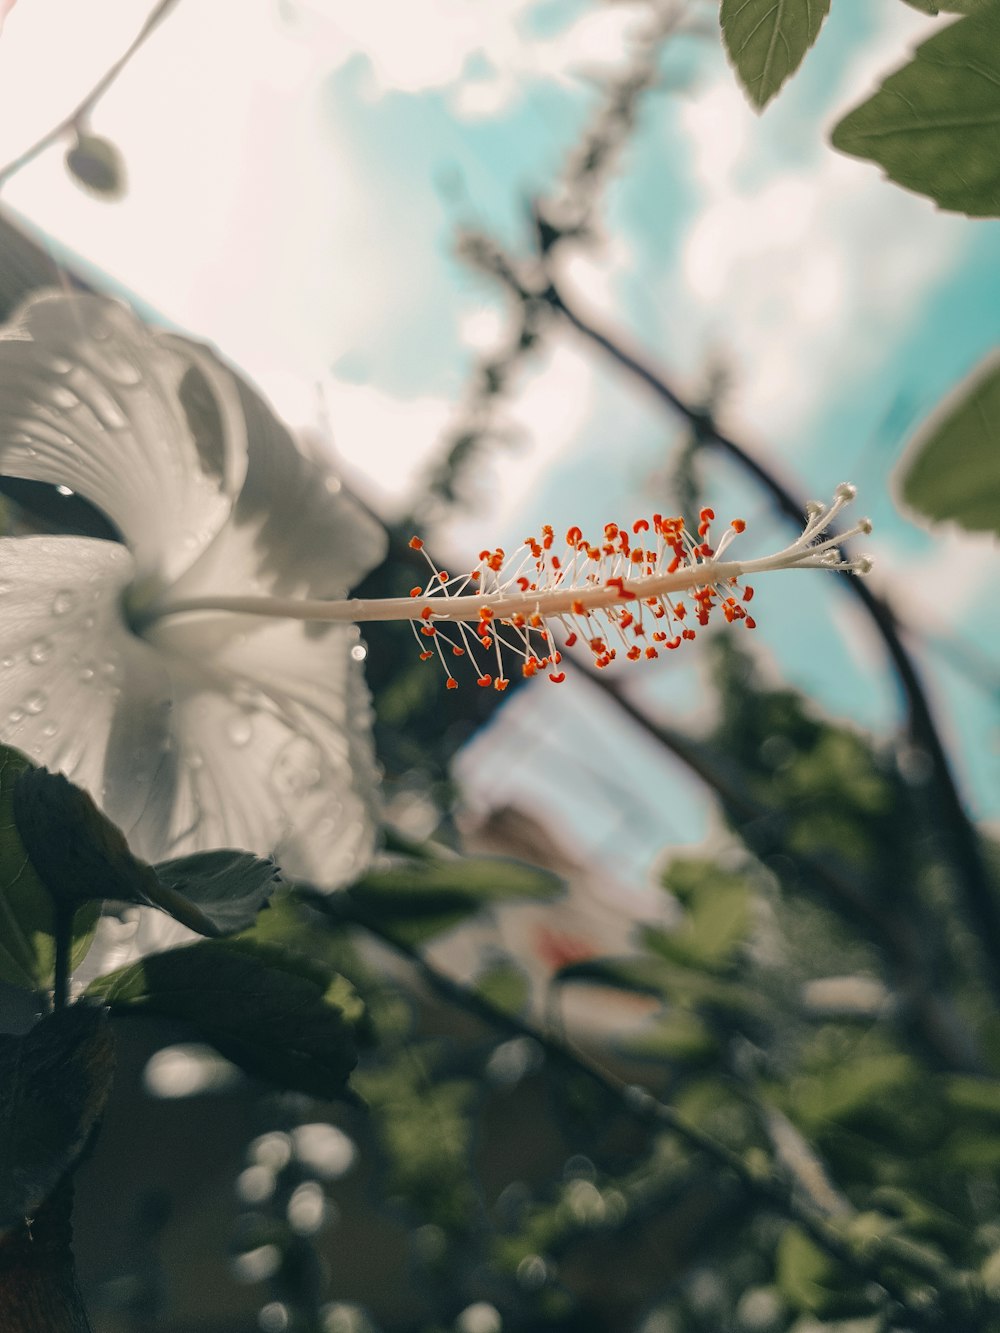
[{"x1": 164, "y1": 367, "x2": 387, "y2": 597}]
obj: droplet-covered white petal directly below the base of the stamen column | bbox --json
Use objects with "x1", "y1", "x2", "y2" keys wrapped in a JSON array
[{"x1": 133, "y1": 617, "x2": 377, "y2": 888}]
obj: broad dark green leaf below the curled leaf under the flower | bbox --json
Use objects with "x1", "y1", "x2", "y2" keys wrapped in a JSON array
[{"x1": 88, "y1": 940, "x2": 357, "y2": 1097}]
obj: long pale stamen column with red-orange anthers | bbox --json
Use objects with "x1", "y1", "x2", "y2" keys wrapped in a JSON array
[{"x1": 140, "y1": 484, "x2": 872, "y2": 690}]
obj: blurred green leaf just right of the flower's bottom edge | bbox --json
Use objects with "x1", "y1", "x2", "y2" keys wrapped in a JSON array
[{"x1": 347, "y1": 857, "x2": 563, "y2": 945}]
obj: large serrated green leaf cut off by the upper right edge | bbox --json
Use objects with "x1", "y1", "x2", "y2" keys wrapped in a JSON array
[{"x1": 832, "y1": 8, "x2": 1000, "y2": 217}]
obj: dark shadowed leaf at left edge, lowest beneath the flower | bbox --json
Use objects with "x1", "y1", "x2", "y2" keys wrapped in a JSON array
[{"x1": 0, "y1": 1004, "x2": 113, "y2": 1229}]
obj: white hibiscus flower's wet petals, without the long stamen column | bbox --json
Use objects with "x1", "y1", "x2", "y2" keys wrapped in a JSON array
[{"x1": 0, "y1": 295, "x2": 385, "y2": 888}]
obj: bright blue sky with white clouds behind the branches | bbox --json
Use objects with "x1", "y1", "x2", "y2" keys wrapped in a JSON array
[{"x1": 0, "y1": 0, "x2": 1000, "y2": 874}]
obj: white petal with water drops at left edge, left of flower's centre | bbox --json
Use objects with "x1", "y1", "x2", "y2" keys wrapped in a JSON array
[{"x1": 0, "y1": 527, "x2": 169, "y2": 799}]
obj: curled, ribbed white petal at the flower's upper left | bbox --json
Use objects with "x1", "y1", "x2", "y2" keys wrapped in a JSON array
[{"x1": 0, "y1": 295, "x2": 247, "y2": 581}]
